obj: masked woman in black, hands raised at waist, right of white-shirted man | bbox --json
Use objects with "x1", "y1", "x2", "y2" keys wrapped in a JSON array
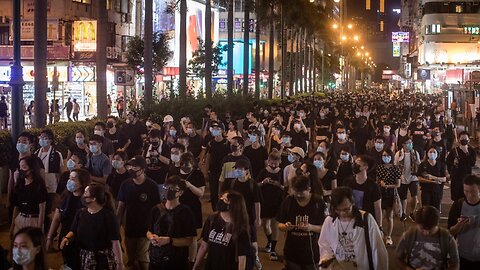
[{"x1": 417, "y1": 146, "x2": 447, "y2": 210}]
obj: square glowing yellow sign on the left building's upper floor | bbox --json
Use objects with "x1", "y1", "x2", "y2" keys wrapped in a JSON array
[{"x1": 73, "y1": 21, "x2": 97, "y2": 52}]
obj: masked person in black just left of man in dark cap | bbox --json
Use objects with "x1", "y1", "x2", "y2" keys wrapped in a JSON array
[{"x1": 107, "y1": 151, "x2": 131, "y2": 201}]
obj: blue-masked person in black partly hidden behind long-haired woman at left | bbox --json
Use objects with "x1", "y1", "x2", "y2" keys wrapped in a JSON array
[{"x1": 46, "y1": 168, "x2": 90, "y2": 270}]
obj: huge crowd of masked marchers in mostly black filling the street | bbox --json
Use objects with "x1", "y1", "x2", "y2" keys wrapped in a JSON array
[{"x1": 0, "y1": 91, "x2": 480, "y2": 270}]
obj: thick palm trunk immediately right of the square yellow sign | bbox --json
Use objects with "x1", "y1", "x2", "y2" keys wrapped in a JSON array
[{"x1": 96, "y1": 0, "x2": 108, "y2": 119}]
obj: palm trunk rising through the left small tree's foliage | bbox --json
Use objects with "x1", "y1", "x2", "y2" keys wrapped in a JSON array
[{"x1": 143, "y1": 1, "x2": 153, "y2": 106}]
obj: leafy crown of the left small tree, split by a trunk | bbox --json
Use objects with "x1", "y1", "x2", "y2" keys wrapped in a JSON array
[{"x1": 126, "y1": 32, "x2": 173, "y2": 73}]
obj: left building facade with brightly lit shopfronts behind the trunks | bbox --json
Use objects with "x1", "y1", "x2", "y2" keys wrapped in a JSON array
[{"x1": 0, "y1": 0, "x2": 135, "y2": 116}]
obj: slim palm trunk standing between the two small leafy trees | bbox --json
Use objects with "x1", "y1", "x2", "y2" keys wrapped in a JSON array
[{"x1": 178, "y1": 0, "x2": 187, "y2": 99}]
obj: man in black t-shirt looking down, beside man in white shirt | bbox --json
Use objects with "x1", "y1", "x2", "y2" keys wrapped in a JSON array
[{"x1": 277, "y1": 176, "x2": 326, "y2": 270}]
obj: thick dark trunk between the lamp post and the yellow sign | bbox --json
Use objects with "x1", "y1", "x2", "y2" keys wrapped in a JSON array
[{"x1": 33, "y1": 0, "x2": 48, "y2": 127}]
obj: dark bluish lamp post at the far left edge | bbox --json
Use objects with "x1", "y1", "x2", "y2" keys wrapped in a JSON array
[{"x1": 9, "y1": 0, "x2": 25, "y2": 140}]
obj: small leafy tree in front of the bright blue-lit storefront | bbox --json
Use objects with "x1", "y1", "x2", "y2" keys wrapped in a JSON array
[{"x1": 188, "y1": 39, "x2": 227, "y2": 79}]
